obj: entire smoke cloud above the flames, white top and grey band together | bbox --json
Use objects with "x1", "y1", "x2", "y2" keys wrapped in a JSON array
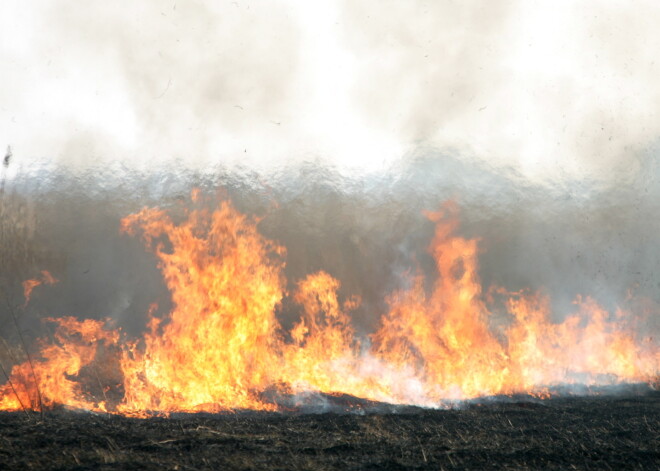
[{"x1": 0, "y1": 0, "x2": 660, "y2": 350}]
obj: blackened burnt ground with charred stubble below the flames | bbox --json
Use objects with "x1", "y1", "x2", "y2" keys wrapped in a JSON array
[{"x1": 0, "y1": 392, "x2": 660, "y2": 470}]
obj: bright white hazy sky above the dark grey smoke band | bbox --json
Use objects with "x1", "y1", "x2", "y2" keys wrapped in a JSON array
[{"x1": 0, "y1": 0, "x2": 660, "y2": 184}]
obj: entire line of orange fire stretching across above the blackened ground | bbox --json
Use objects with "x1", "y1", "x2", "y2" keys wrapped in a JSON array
[{"x1": 0, "y1": 194, "x2": 660, "y2": 416}]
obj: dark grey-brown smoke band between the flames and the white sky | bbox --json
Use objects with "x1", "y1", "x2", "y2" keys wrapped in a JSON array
[{"x1": 2, "y1": 150, "x2": 660, "y2": 340}]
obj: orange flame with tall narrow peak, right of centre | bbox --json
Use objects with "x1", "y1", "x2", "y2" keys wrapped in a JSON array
[{"x1": 373, "y1": 204, "x2": 508, "y2": 400}]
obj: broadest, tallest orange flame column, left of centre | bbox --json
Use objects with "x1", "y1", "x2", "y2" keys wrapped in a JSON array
[{"x1": 116, "y1": 203, "x2": 285, "y2": 411}]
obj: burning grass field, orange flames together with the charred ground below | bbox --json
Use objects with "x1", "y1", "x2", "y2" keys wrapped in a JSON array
[{"x1": 0, "y1": 192, "x2": 660, "y2": 470}]
